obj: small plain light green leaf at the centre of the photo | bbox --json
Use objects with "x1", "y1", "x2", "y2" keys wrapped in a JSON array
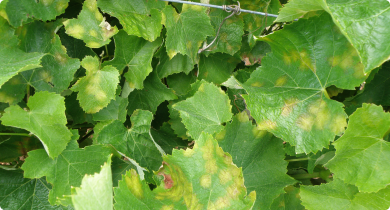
[{"x1": 172, "y1": 83, "x2": 232, "y2": 139}]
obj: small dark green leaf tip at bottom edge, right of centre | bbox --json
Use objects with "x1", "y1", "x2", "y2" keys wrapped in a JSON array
[{"x1": 271, "y1": 186, "x2": 305, "y2": 210}]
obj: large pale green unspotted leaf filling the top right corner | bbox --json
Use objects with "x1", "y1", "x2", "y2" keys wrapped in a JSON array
[{"x1": 277, "y1": 0, "x2": 390, "y2": 72}]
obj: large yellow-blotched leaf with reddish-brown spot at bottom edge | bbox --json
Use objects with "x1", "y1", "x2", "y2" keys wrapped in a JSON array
[{"x1": 114, "y1": 133, "x2": 256, "y2": 209}]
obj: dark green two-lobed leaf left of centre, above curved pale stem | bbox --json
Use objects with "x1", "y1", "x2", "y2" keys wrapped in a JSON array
[{"x1": 93, "y1": 110, "x2": 162, "y2": 170}]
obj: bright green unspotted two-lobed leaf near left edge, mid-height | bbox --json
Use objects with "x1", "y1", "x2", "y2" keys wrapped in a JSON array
[{"x1": 1, "y1": 92, "x2": 72, "y2": 158}]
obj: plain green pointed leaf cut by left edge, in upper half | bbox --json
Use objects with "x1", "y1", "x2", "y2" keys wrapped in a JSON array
[{"x1": 0, "y1": 17, "x2": 45, "y2": 87}]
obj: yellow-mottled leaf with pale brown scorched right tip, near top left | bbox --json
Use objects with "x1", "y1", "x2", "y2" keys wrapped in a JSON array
[{"x1": 64, "y1": 0, "x2": 118, "y2": 48}]
